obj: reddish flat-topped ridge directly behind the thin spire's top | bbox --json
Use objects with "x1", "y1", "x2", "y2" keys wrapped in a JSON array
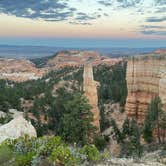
[{"x1": 46, "y1": 51, "x2": 122, "y2": 69}]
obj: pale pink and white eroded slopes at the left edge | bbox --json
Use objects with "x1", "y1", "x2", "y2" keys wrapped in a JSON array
[{"x1": 0, "y1": 58, "x2": 44, "y2": 82}]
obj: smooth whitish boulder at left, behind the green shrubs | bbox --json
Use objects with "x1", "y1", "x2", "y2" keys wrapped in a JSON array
[{"x1": 0, "y1": 116, "x2": 37, "y2": 143}]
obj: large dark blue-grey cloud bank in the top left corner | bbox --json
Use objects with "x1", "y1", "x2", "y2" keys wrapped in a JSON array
[{"x1": 0, "y1": 0, "x2": 76, "y2": 21}]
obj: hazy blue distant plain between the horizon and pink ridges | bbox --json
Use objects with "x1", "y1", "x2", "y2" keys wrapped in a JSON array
[{"x1": 0, "y1": 45, "x2": 156, "y2": 59}]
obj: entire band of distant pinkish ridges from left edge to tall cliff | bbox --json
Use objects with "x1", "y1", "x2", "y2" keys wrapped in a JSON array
[{"x1": 0, "y1": 50, "x2": 122, "y2": 82}]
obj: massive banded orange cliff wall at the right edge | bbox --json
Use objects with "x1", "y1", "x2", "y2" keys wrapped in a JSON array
[{"x1": 126, "y1": 54, "x2": 166, "y2": 124}]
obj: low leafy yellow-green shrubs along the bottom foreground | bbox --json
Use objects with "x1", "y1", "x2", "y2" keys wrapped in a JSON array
[{"x1": 0, "y1": 136, "x2": 104, "y2": 166}]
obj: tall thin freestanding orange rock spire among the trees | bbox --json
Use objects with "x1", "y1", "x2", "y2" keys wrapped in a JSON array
[{"x1": 83, "y1": 63, "x2": 100, "y2": 131}]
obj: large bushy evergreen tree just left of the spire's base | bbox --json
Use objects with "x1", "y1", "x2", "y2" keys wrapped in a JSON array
[{"x1": 59, "y1": 93, "x2": 95, "y2": 144}]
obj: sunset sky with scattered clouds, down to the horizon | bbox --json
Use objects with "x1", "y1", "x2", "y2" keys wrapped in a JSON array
[{"x1": 0, "y1": 0, "x2": 166, "y2": 47}]
